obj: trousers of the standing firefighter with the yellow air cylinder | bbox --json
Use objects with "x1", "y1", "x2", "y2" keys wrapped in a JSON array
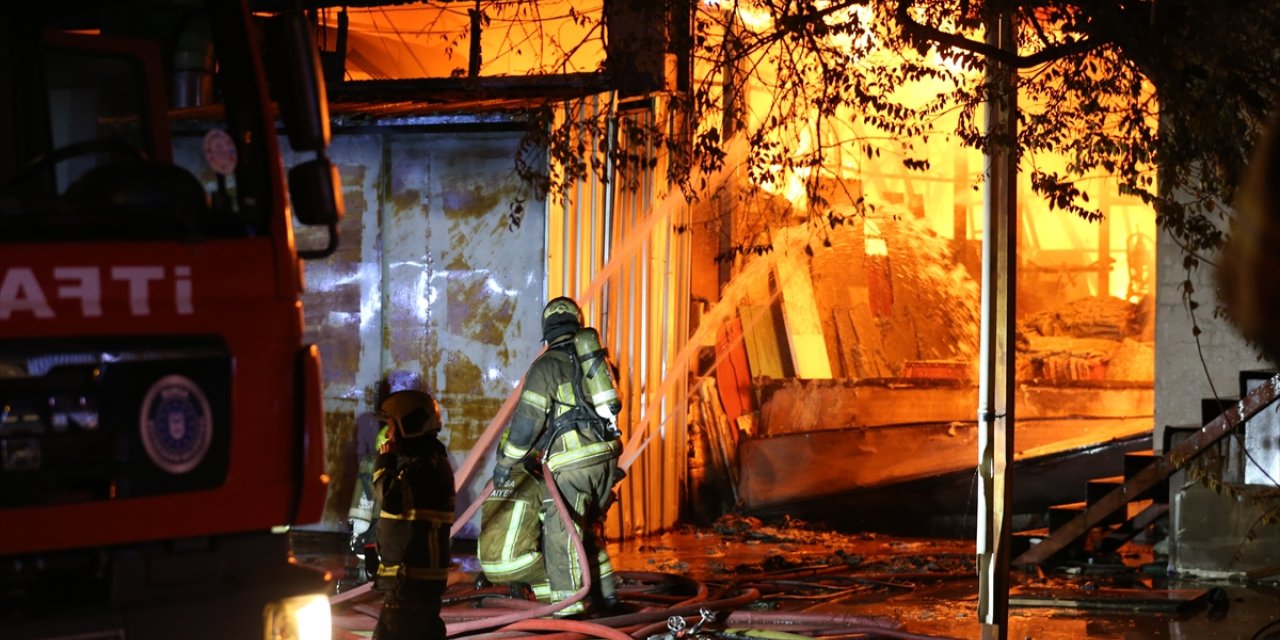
[{"x1": 543, "y1": 433, "x2": 618, "y2": 616}]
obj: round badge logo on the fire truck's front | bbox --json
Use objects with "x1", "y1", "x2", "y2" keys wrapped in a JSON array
[{"x1": 140, "y1": 375, "x2": 214, "y2": 474}]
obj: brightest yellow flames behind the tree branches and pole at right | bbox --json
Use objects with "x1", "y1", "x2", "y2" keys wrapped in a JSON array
[{"x1": 704, "y1": 1, "x2": 1156, "y2": 311}]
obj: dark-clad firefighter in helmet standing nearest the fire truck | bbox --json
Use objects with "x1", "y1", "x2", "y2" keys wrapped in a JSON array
[{"x1": 374, "y1": 390, "x2": 454, "y2": 640}]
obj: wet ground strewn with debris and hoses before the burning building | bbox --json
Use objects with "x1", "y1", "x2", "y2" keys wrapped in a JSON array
[{"x1": 302, "y1": 516, "x2": 1280, "y2": 640}]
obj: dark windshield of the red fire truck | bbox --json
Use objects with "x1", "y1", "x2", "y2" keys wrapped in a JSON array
[{"x1": 0, "y1": 1, "x2": 284, "y2": 242}]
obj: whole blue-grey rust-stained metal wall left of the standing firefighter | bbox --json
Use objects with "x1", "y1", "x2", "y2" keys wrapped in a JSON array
[{"x1": 300, "y1": 127, "x2": 545, "y2": 522}]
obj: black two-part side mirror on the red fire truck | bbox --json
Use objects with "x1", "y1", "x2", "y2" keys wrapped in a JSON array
[{"x1": 264, "y1": 12, "x2": 344, "y2": 259}]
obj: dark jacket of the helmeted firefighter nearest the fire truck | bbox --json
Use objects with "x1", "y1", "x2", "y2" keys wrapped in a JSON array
[{"x1": 374, "y1": 435, "x2": 454, "y2": 580}]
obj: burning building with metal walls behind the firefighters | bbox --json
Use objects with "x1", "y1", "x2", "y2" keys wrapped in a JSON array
[{"x1": 252, "y1": 1, "x2": 1280, "y2": 637}]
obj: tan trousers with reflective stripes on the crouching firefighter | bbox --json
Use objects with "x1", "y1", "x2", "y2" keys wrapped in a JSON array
[{"x1": 476, "y1": 465, "x2": 550, "y2": 602}]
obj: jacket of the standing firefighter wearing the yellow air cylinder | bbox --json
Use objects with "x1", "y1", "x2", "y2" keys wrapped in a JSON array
[{"x1": 497, "y1": 335, "x2": 621, "y2": 472}]
